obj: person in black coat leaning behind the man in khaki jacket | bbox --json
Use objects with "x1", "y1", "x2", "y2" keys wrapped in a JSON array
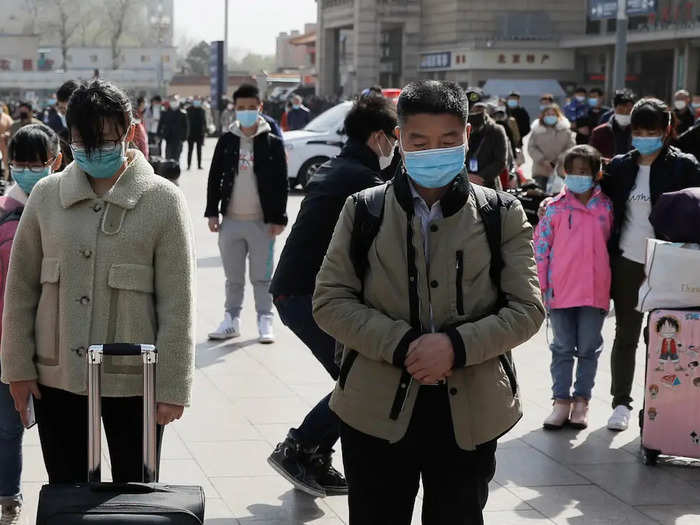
[{"x1": 268, "y1": 97, "x2": 397, "y2": 496}]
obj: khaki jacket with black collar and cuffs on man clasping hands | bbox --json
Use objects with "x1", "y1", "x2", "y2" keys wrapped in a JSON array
[{"x1": 313, "y1": 175, "x2": 544, "y2": 450}]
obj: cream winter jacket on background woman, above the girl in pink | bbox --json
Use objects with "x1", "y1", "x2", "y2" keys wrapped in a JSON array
[{"x1": 527, "y1": 118, "x2": 576, "y2": 177}]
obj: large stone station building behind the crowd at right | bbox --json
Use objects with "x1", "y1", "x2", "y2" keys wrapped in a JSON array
[{"x1": 317, "y1": 0, "x2": 700, "y2": 105}]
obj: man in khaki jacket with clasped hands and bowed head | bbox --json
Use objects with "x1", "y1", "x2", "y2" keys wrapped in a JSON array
[{"x1": 314, "y1": 81, "x2": 544, "y2": 525}]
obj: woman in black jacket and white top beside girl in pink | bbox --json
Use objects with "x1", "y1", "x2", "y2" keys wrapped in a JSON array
[{"x1": 601, "y1": 98, "x2": 700, "y2": 431}]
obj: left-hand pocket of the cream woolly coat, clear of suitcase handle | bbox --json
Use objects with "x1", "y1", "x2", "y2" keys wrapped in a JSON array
[{"x1": 34, "y1": 257, "x2": 61, "y2": 366}]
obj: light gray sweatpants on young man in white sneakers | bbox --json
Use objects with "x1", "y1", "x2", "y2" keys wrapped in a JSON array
[{"x1": 219, "y1": 218, "x2": 275, "y2": 317}]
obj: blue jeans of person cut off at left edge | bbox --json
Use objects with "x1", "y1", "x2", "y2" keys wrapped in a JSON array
[{"x1": 0, "y1": 362, "x2": 24, "y2": 504}]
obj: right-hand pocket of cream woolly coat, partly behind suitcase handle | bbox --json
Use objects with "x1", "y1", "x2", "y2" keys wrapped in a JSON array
[{"x1": 105, "y1": 264, "x2": 157, "y2": 374}]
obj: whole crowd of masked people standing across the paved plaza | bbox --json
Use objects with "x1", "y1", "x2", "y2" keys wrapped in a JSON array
[{"x1": 0, "y1": 74, "x2": 700, "y2": 525}]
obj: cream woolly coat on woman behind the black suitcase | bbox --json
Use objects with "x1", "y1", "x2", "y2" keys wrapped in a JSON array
[{"x1": 0, "y1": 150, "x2": 195, "y2": 405}]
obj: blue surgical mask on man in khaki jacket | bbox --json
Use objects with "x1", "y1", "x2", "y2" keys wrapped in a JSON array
[{"x1": 401, "y1": 139, "x2": 466, "y2": 188}]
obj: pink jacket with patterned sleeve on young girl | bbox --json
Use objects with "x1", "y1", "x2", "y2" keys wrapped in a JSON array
[{"x1": 535, "y1": 186, "x2": 613, "y2": 311}]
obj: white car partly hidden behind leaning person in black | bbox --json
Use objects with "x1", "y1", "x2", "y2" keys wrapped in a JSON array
[{"x1": 284, "y1": 101, "x2": 352, "y2": 188}]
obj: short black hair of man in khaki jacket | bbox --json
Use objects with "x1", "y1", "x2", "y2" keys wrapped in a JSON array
[{"x1": 396, "y1": 80, "x2": 469, "y2": 124}]
